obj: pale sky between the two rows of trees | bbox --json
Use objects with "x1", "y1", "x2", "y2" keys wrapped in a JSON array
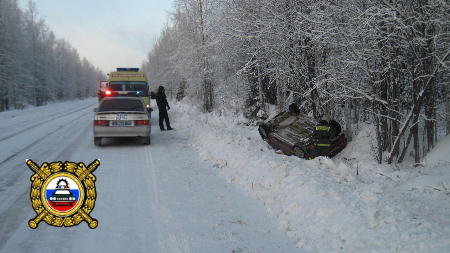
[{"x1": 19, "y1": 0, "x2": 173, "y2": 74}]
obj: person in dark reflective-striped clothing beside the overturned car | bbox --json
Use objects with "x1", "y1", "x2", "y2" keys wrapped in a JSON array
[{"x1": 309, "y1": 116, "x2": 335, "y2": 159}]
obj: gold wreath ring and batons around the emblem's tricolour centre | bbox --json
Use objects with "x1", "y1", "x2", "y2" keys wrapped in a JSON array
[{"x1": 27, "y1": 160, "x2": 100, "y2": 229}]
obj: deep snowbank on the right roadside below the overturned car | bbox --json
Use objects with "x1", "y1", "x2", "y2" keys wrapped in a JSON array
[{"x1": 170, "y1": 102, "x2": 450, "y2": 252}]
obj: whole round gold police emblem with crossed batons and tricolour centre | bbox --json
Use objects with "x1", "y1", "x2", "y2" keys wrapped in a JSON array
[{"x1": 27, "y1": 160, "x2": 100, "y2": 229}]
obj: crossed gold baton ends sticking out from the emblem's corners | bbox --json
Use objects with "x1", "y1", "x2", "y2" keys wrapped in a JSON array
[{"x1": 27, "y1": 159, "x2": 100, "y2": 229}]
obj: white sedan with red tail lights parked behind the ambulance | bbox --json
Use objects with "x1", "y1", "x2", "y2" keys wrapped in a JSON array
[{"x1": 93, "y1": 97, "x2": 151, "y2": 146}]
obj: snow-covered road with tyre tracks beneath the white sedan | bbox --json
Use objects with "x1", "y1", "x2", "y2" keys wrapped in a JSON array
[{"x1": 0, "y1": 99, "x2": 299, "y2": 252}]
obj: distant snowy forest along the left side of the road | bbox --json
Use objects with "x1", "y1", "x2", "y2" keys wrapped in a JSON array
[{"x1": 0, "y1": 0, "x2": 106, "y2": 111}]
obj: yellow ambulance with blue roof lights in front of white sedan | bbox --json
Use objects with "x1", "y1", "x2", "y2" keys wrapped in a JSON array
[{"x1": 104, "y1": 68, "x2": 153, "y2": 113}]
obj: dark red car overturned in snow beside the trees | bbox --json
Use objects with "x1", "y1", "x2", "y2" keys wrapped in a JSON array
[{"x1": 258, "y1": 104, "x2": 347, "y2": 159}]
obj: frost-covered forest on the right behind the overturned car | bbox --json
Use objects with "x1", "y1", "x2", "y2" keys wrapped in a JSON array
[{"x1": 143, "y1": 0, "x2": 450, "y2": 164}]
